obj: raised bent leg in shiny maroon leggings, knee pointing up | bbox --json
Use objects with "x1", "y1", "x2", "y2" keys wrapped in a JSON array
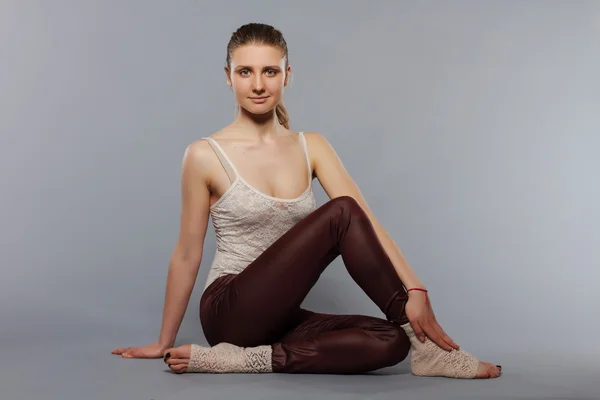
[{"x1": 200, "y1": 196, "x2": 408, "y2": 347}]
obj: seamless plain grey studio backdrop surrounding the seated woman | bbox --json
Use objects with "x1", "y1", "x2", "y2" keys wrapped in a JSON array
[{"x1": 0, "y1": 0, "x2": 600, "y2": 399}]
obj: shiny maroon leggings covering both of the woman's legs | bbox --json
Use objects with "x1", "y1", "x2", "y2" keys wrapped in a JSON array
[{"x1": 200, "y1": 196, "x2": 410, "y2": 374}]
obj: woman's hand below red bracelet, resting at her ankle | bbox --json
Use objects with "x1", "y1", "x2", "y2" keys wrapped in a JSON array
[{"x1": 405, "y1": 290, "x2": 459, "y2": 351}]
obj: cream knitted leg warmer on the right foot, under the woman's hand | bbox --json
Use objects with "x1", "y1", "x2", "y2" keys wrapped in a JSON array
[{"x1": 401, "y1": 323, "x2": 479, "y2": 379}]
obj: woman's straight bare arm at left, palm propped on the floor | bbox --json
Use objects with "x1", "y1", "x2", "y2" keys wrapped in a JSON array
[{"x1": 112, "y1": 141, "x2": 210, "y2": 358}]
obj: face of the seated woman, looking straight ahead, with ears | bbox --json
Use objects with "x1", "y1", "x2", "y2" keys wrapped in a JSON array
[{"x1": 225, "y1": 45, "x2": 291, "y2": 114}]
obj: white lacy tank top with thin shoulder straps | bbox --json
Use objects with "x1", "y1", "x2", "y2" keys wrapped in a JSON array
[{"x1": 202, "y1": 132, "x2": 316, "y2": 289}]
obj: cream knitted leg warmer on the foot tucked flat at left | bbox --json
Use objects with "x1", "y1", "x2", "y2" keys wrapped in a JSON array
[{"x1": 187, "y1": 343, "x2": 273, "y2": 373}]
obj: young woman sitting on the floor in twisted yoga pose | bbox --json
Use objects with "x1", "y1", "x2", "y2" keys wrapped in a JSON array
[{"x1": 113, "y1": 23, "x2": 501, "y2": 378}]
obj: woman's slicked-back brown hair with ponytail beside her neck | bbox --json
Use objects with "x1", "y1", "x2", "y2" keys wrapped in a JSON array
[{"x1": 225, "y1": 22, "x2": 290, "y2": 129}]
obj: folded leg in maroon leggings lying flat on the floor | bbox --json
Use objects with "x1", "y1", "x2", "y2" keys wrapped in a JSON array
[{"x1": 272, "y1": 310, "x2": 410, "y2": 374}]
